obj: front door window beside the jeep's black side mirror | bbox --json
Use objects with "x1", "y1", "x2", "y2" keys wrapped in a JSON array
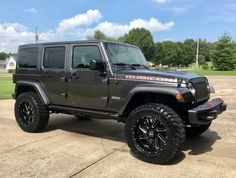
[{"x1": 72, "y1": 45, "x2": 102, "y2": 68}]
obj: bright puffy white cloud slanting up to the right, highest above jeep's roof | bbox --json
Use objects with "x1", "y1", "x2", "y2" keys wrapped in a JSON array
[{"x1": 57, "y1": 9, "x2": 102, "y2": 33}]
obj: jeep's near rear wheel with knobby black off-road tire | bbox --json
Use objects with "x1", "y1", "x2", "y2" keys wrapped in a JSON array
[{"x1": 15, "y1": 92, "x2": 49, "y2": 133}]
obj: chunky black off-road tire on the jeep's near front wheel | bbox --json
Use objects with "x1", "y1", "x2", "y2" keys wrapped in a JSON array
[{"x1": 125, "y1": 103, "x2": 185, "y2": 164}]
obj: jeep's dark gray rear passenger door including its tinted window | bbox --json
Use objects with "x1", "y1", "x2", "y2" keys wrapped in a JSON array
[{"x1": 42, "y1": 45, "x2": 67, "y2": 104}]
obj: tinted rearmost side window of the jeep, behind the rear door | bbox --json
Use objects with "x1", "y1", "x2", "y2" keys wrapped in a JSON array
[{"x1": 18, "y1": 48, "x2": 39, "y2": 68}]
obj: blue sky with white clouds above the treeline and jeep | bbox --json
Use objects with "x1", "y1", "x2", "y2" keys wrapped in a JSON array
[{"x1": 0, "y1": 0, "x2": 236, "y2": 52}]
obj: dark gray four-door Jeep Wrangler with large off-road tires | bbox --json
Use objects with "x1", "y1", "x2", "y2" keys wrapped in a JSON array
[{"x1": 13, "y1": 41, "x2": 226, "y2": 164}]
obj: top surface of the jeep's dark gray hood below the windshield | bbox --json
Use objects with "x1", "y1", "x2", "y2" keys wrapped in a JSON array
[{"x1": 119, "y1": 69, "x2": 204, "y2": 82}]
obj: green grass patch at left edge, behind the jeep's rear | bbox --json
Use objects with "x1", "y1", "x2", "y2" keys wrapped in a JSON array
[{"x1": 0, "y1": 77, "x2": 15, "y2": 99}]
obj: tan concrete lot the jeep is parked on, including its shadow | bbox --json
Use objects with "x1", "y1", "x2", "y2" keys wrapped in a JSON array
[{"x1": 0, "y1": 76, "x2": 236, "y2": 178}]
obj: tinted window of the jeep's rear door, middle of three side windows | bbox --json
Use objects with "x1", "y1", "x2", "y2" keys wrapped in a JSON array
[{"x1": 43, "y1": 46, "x2": 66, "y2": 69}]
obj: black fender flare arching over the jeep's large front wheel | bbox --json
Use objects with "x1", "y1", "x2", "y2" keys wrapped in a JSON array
[{"x1": 118, "y1": 86, "x2": 193, "y2": 116}]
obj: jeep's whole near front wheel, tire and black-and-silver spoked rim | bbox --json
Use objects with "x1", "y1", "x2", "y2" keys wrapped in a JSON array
[{"x1": 125, "y1": 103, "x2": 185, "y2": 164}]
